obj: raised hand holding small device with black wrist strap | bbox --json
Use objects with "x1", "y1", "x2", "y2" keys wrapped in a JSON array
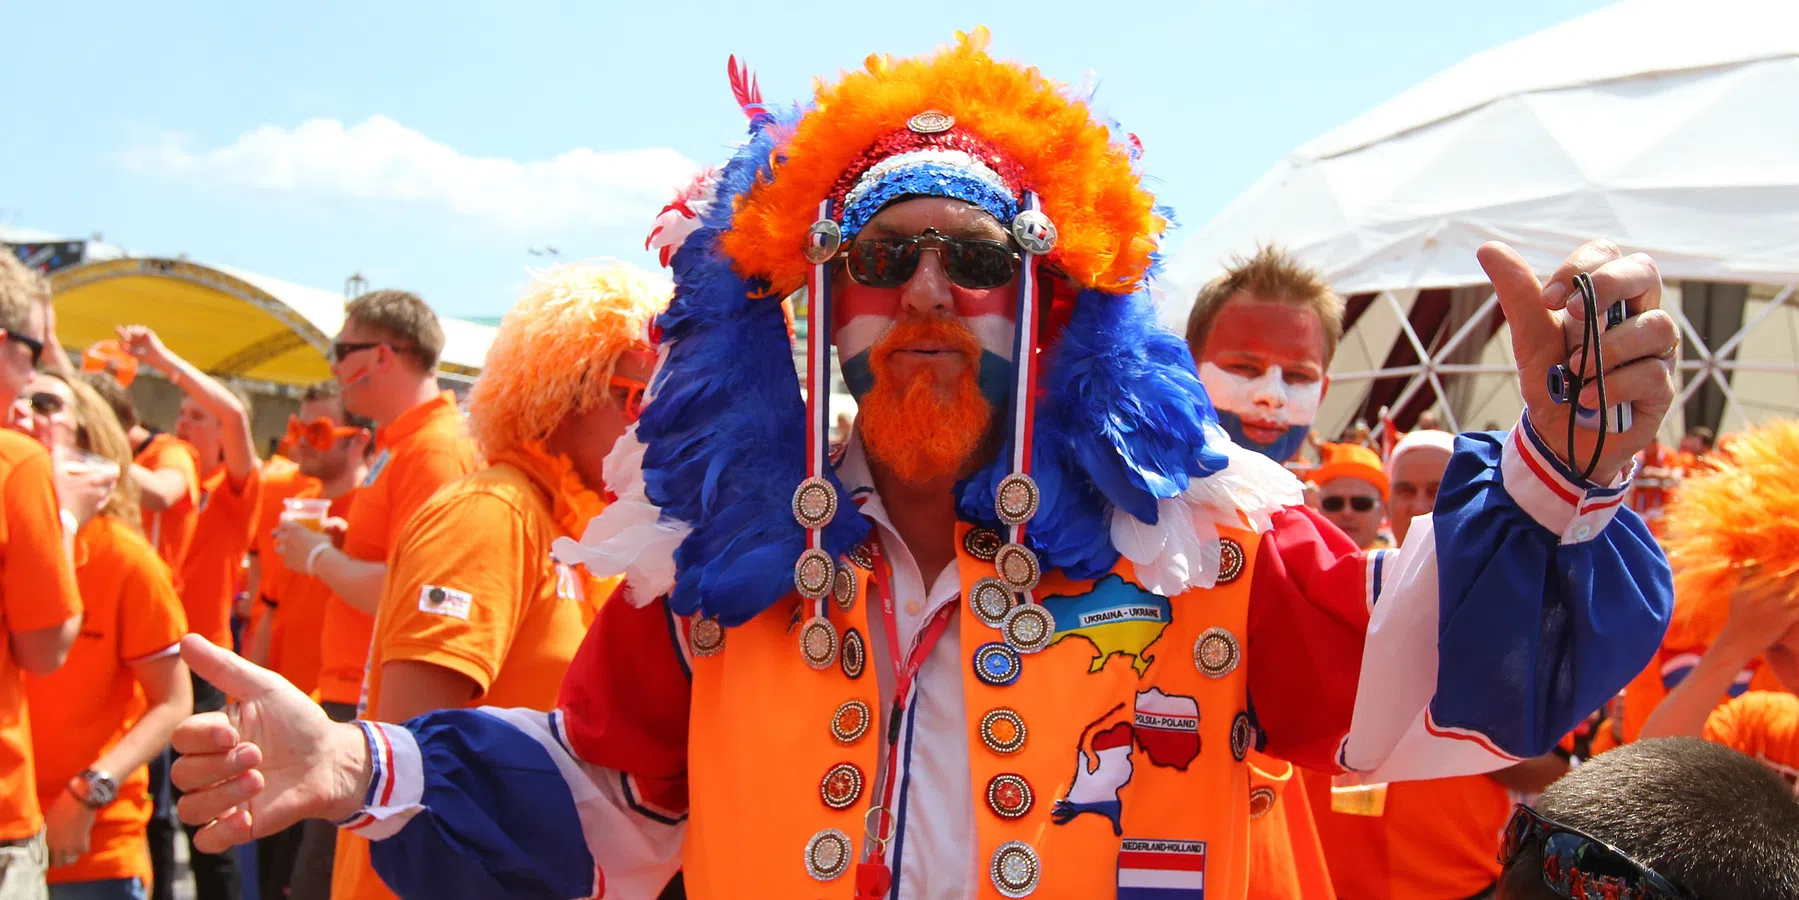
[{"x1": 1475, "y1": 241, "x2": 1680, "y2": 484}]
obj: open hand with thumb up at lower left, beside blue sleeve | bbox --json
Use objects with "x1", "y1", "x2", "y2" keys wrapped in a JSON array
[{"x1": 169, "y1": 634, "x2": 369, "y2": 853}]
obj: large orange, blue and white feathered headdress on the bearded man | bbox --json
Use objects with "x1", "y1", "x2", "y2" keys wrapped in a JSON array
[{"x1": 558, "y1": 29, "x2": 1301, "y2": 626}]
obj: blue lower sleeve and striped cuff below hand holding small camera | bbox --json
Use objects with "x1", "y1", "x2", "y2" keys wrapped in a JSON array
[{"x1": 1428, "y1": 421, "x2": 1673, "y2": 758}]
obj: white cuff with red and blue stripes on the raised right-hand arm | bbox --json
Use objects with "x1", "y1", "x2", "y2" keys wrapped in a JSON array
[{"x1": 1499, "y1": 416, "x2": 1637, "y2": 544}]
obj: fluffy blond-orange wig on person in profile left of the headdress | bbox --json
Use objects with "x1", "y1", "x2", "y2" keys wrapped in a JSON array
[{"x1": 468, "y1": 263, "x2": 673, "y2": 459}]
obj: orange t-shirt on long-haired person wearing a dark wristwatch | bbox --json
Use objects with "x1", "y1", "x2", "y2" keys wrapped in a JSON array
[{"x1": 25, "y1": 517, "x2": 187, "y2": 884}]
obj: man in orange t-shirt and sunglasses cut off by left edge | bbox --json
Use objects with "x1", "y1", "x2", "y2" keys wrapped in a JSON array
[{"x1": 0, "y1": 259, "x2": 93, "y2": 900}]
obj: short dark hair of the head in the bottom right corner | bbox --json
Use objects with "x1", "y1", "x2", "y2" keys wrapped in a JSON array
[{"x1": 1499, "y1": 738, "x2": 1799, "y2": 900}]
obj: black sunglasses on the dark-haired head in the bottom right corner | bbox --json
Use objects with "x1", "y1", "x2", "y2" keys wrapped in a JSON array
[{"x1": 1499, "y1": 805, "x2": 1691, "y2": 900}]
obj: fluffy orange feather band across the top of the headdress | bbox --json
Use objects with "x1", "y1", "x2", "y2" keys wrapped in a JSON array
[{"x1": 720, "y1": 29, "x2": 1168, "y2": 295}]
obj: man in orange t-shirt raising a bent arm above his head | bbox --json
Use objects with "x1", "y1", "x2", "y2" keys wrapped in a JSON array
[{"x1": 119, "y1": 326, "x2": 263, "y2": 900}]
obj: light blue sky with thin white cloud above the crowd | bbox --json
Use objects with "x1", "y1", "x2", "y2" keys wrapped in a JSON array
[{"x1": 0, "y1": 0, "x2": 1603, "y2": 317}]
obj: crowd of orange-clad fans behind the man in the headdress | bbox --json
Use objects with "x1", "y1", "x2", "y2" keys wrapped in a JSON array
[{"x1": 0, "y1": 225, "x2": 1799, "y2": 900}]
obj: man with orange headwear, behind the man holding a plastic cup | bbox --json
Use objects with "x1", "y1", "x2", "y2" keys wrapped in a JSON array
[{"x1": 246, "y1": 382, "x2": 374, "y2": 900}]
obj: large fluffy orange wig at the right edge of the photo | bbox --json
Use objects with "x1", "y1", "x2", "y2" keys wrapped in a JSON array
[{"x1": 1662, "y1": 421, "x2": 1799, "y2": 646}]
